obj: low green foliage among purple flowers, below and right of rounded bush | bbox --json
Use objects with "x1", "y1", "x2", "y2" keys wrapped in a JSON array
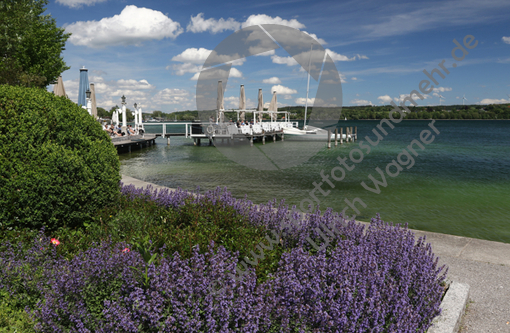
[{"x1": 48, "y1": 196, "x2": 284, "y2": 281}]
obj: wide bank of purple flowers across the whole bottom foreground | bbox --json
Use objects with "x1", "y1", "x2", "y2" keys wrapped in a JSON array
[{"x1": 0, "y1": 211, "x2": 446, "y2": 332}]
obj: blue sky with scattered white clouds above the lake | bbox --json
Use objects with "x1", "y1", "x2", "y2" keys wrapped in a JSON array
[{"x1": 46, "y1": 0, "x2": 510, "y2": 112}]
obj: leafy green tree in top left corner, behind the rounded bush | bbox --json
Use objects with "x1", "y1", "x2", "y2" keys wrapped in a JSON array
[{"x1": 0, "y1": 0, "x2": 71, "y2": 88}]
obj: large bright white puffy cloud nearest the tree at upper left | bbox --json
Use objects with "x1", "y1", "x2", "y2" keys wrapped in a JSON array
[{"x1": 65, "y1": 5, "x2": 183, "y2": 48}]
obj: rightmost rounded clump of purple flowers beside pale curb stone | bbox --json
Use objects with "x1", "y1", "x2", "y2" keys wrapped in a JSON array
[{"x1": 266, "y1": 218, "x2": 446, "y2": 332}]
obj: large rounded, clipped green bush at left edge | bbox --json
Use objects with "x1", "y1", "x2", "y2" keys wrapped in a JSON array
[{"x1": 0, "y1": 85, "x2": 120, "y2": 230}]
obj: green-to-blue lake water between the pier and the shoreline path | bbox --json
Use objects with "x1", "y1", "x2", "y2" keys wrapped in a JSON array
[{"x1": 120, "y1": 120, "x2": 510, "y2": 243}]
